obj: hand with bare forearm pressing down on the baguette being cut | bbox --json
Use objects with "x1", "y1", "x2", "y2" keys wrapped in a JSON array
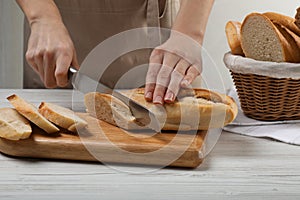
[{"x1": 145, "y1": 0, "x2": 214, "y2": 104}]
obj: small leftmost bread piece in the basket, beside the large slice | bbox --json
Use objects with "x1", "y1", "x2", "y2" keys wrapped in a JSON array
[{"x1": 225, "y1": 21, "x2": 244, "y2": 56}]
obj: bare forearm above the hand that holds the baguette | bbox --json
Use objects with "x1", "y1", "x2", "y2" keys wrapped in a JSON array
[{"x1": 172, "y1": 0, "x2": 214, "y2": 44}]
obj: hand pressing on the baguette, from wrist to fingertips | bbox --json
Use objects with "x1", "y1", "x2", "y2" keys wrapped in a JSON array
[{"x1": 145, "y1": 31, "x2": 202, "y2": 104}]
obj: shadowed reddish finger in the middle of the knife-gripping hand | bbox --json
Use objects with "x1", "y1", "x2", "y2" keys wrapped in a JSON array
[{"x1": 44, "y1": 52, "x2": 57, "y2": 88}]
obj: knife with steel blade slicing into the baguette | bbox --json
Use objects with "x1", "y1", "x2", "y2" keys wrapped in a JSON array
[{"x1": 69, "y1": 67, "x2": 161, "y2": 132}]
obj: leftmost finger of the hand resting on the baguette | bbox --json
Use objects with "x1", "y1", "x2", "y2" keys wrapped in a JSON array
[{"x1": 145, "y1": 49, "x2": 163, "y2": 101}]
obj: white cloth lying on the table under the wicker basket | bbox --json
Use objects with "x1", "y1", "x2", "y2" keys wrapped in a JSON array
[{"x1": 223, "y1": 88, "x2": 300, "y2": 145}]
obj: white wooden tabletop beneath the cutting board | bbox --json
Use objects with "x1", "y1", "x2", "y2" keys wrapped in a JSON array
[{"x1": 0, "y1": 89, "x2": 300, "y2": 200}]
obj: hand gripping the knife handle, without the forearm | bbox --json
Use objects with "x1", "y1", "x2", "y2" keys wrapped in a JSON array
[{"x1": 26, "y1": 19, "x2": 79, "y2": 88}]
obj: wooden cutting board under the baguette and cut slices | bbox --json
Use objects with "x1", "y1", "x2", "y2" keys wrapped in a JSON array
[{"x1": 0, "y1": 113, "x2": 206, "y2": 168}]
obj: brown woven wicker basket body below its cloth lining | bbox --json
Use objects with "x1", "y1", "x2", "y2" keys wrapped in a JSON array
[{"x1": 224, "y1": 52, "x2": 300, "y2": 121}]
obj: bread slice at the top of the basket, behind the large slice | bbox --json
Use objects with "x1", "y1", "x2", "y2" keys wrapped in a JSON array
[{"x1": 263, "y1": 12, "x2": 300, "y2": 36}]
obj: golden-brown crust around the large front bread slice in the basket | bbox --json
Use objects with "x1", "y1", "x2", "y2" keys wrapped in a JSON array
[{"x1": 241, "y1": 13, "x2": 300, "y2": 62}]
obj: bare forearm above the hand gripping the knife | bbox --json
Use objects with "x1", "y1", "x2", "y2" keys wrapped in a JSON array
[{"x1": 16, "y1": 0, "x2": 62, "y2": 25}]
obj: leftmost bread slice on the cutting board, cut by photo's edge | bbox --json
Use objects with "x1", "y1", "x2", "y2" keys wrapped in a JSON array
[{"x1": 0, "y1": 108, "x2": 32, "y2": 140}]
